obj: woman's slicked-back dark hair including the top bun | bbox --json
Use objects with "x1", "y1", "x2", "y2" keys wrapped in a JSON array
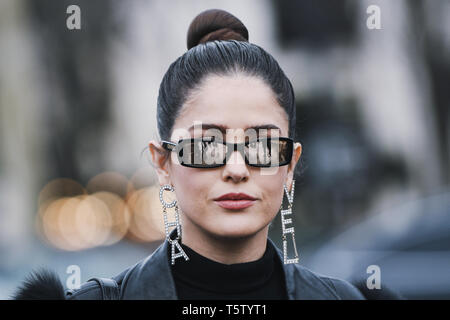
[{"x1": 157, "y1": 9, "x2": 296, "y2": 140}]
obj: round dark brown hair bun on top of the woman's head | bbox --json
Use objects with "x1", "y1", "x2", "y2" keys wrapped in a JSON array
[{"x1": 187, "y1": 9, "x2": 248, "y2": 50}]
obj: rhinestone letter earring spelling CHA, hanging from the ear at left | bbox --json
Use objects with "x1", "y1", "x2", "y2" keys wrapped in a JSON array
[{"x1": 159, "y1": 184, "x2": 189, "y2": 265}]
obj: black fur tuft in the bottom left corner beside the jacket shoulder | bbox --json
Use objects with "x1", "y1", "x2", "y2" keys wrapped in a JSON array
[{"x1": 12, "y1": 269, "x2": 66, "y2": 300}]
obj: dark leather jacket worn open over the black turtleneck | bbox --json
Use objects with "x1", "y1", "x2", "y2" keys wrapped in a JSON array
[{"x1": 66, "y1": 239, "x2": 364, "y2": 300}]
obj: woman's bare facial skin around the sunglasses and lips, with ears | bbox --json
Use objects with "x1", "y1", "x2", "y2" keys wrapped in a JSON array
[{"x1": 151, "y1": 75, "x2": 301, "y2": 238}]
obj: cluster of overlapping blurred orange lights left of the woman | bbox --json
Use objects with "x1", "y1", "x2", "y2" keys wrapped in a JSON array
[{"x1": 36, "y1": 170, "x2": 168, "y2": 251}]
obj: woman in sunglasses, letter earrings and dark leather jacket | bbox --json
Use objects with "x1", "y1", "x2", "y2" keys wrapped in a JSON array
[{"x1": 14, "y1": 10, "x2": 363, "y2": 299}]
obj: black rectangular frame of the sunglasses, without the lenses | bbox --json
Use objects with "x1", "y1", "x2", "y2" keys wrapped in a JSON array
[{"x1": 161, "y1": 137, "x2": 294, "y2": 169}]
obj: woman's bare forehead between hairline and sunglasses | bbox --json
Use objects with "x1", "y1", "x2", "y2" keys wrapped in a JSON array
[{"x1": 174, "y1": 77, "x2": 289, "y2": 139}]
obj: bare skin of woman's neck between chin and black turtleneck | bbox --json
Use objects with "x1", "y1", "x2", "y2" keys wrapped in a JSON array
[{"x1": 181, "y1": 221, "x2": 269, "y2": 264}]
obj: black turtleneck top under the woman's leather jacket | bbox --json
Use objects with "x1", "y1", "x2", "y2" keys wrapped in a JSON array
[{"x1": 169, "y1": 241, "x2": 287, "y2": 300}]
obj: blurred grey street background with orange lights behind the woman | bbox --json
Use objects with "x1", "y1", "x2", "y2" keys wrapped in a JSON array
[{"x1": 0, "y1": 0, "x2": 450, "y2": 299}]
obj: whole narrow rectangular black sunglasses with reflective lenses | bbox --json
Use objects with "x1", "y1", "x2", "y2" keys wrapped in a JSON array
[{"x1": 161, "y1": 137, "x2": 294, "y2": 168}]
